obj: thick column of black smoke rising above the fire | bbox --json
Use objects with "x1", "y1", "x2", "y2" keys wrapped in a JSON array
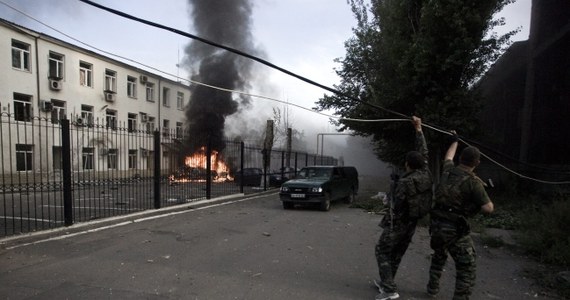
[{"x1": 185, "y1": 0, "x2": 257, "y2": 152}]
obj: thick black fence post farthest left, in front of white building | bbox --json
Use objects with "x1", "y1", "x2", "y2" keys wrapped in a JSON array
[{"x1": 60, "y1": 119, "x2": 73, "y2": 226}]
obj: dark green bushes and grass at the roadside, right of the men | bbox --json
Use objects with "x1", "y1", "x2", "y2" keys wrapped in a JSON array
[{"x1": 472, "y1": 192, "x2": 570, "y2": 298}]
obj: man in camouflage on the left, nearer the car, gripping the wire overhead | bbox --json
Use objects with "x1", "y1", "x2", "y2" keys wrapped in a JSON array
[{"x1": 375, "y1": 116, "x2": 432, "y2": 300}]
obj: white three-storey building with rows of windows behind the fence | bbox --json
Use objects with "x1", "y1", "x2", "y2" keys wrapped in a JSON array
[{"x1": 0, "y1": 19, "x2": 190, "y2": 179}]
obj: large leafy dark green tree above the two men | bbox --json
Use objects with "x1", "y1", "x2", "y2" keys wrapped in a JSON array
[{"x1": 317, "y1": 0, "x2": 517, "y2": 165}]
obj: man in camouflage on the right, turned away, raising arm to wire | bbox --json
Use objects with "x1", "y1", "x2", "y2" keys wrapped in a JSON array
[{"x1": 427, "y1": 135, "x2": 494, "y2": 299}]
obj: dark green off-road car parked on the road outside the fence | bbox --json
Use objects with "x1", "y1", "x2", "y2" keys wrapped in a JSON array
[{"x1": 279, "y1": 166, "x2": 358, "y2": 211}]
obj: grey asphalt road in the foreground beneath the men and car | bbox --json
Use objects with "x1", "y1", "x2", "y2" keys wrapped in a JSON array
[{"x1": 0, "y1": 193, "x2": 560, "y2": 300}]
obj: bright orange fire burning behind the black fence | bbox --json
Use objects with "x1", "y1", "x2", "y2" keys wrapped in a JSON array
[{"x1": 171, "y1": 147, "x2": 233, "y2": 182}]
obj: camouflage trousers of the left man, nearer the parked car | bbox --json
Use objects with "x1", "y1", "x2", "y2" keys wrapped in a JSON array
[{"x1": 375, "y1": 221, "x2": 417, "y2": 293}]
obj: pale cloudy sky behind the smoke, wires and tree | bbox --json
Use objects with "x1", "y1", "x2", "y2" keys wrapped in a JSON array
[{"x1": 0, "y1": 0, "x2": 531, "y2": 173}]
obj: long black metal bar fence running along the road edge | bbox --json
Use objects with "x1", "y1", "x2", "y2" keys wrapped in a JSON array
[{"x1": 0, "y1": 113, "x2": 338, "y2": 238}]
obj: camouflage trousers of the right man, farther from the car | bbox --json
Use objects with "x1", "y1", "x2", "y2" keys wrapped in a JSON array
[{"x1": 427, "y1": 220, "x2": 476, "y2": 300}]
